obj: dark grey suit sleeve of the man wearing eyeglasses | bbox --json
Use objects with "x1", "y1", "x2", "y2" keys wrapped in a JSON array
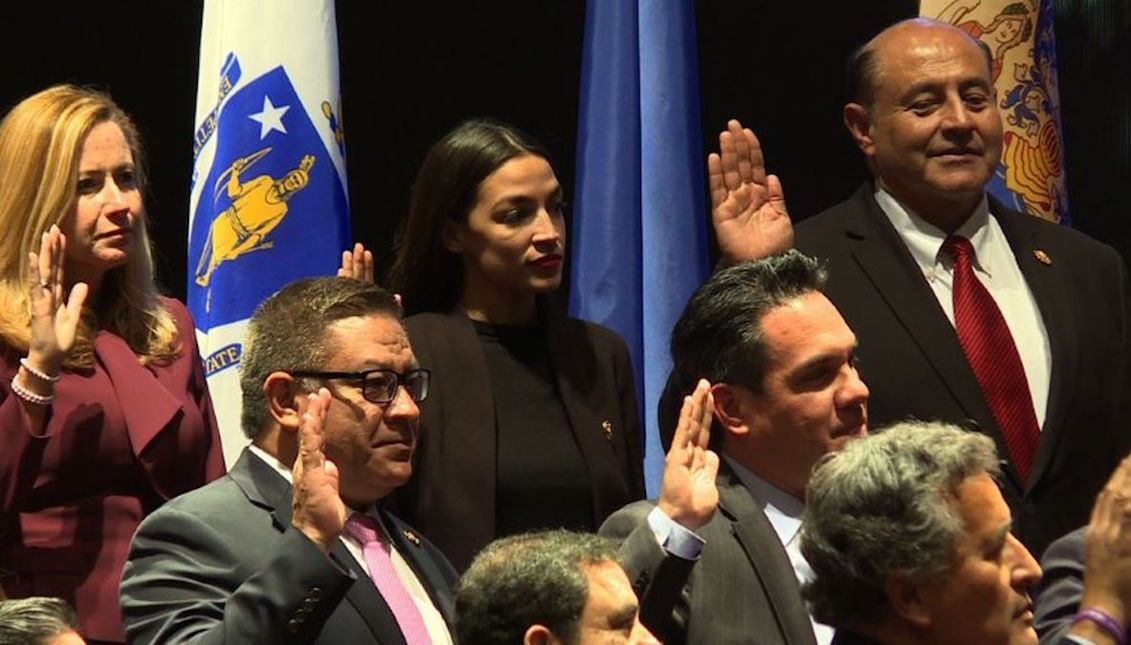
[{"x1": 120, "y1": 506, "x2": 355, "y2": 645}]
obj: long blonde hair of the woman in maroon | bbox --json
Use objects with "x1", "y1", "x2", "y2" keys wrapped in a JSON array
[{"x1": 0, "y1": 85, "x2": 178, "y2": 367}]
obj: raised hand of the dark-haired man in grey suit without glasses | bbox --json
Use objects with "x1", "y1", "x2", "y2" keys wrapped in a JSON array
[{"x1": 658, "y1": 379, "x2": 718, "y2": 531}]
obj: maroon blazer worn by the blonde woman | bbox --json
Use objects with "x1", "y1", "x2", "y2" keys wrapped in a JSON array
[{"x1": 0, "y1": 299, "x2": 224, "y2": 640}]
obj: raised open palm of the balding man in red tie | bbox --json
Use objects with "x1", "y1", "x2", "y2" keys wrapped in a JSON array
[{"x1": 707, "y1": 119, "x2": 793, "y2": 265}]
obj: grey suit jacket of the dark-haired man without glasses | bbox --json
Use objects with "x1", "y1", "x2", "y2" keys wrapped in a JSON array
[{"x1": 601, "y1": 462, "x2": 817, "y2": 645}]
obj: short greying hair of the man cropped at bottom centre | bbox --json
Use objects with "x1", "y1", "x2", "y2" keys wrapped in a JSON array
[{"x1": 456, "y1": 530, "x2": 620, "y2": 645}]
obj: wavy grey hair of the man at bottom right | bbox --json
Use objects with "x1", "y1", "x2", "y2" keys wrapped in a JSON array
[{"x1": 801, "y1": 421, "x2": 1000, "y2": 628}]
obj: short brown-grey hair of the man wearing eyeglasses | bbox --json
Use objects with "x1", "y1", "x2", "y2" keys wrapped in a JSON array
[{"x1": 240, "y1": 277, "x2": 400, "y2": 439}]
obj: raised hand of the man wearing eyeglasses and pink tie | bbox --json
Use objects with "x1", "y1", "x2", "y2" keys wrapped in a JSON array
[{"x1": 291, "y1": 387, "x2": 349, "y2": 553}]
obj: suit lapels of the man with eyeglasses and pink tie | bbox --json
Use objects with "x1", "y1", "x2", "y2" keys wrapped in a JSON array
[{"x1": 230, "y1": 449, "x2": 405, "y2": 645}]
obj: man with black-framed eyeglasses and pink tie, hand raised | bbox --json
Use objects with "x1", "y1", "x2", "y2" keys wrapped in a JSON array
[{"x1": 120, "y1": 277, "x2": 456, "y2": 645}]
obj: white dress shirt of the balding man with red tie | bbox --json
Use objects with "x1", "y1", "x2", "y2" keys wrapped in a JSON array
[{"x1": 875, "y1": 189, "x2": 1052, "y2": 428}]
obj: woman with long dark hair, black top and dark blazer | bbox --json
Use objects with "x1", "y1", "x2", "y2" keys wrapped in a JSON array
[{"x1": 370, "y1": 120, "x2": 645, "y2": 570}]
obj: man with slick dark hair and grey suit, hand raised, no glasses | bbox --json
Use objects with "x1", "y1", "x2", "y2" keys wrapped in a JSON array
[{"x1": 601, "y1": 251, "x2": 869, "y2": 644}]
